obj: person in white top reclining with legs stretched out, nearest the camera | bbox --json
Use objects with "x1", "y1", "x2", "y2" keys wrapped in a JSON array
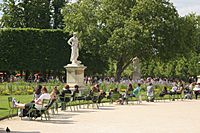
[{"x1": 13, "y1": 86, "x2": 51, "y2": 110}]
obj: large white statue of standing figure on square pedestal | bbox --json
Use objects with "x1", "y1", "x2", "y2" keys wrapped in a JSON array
[{"x1": 68, "y1": 32, "x2": 81, "y2": 65}]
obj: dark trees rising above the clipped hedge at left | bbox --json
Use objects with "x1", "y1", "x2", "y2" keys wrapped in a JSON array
[{"x1": 0, "y1": 0, "x2": 66, "y2": 29}]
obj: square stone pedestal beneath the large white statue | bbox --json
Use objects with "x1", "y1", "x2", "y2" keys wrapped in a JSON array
[{"x1": 64, "y1": 64, "x2": 87, "y2": 88}]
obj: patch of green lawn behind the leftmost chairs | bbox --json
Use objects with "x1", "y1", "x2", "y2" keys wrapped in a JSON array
[{"x1": 0, "y1": 95, "x2": 33, "y2": 118}]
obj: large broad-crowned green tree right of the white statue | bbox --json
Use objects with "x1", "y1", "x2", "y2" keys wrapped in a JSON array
[{"x1": 64, "y1": 0, "x2": 188, "y2": 81}]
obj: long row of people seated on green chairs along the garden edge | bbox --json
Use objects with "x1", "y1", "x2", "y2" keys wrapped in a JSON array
[{"x1": 10, "y1": 78, "x2": 200, "y2": 119}]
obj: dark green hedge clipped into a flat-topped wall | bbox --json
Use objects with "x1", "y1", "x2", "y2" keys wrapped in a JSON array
[{"x1": 0, "y1": 29, "x2": 70, "y2": 71}]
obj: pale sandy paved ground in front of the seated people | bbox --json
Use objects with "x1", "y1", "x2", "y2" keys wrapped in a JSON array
[{"x1": 0, "y1": 100, "x2": 200, "y2": 133}]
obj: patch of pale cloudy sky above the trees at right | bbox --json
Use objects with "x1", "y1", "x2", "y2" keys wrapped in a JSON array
[{"x1": 0, "y1": 0, "x2": 200, "y2": 16}]
